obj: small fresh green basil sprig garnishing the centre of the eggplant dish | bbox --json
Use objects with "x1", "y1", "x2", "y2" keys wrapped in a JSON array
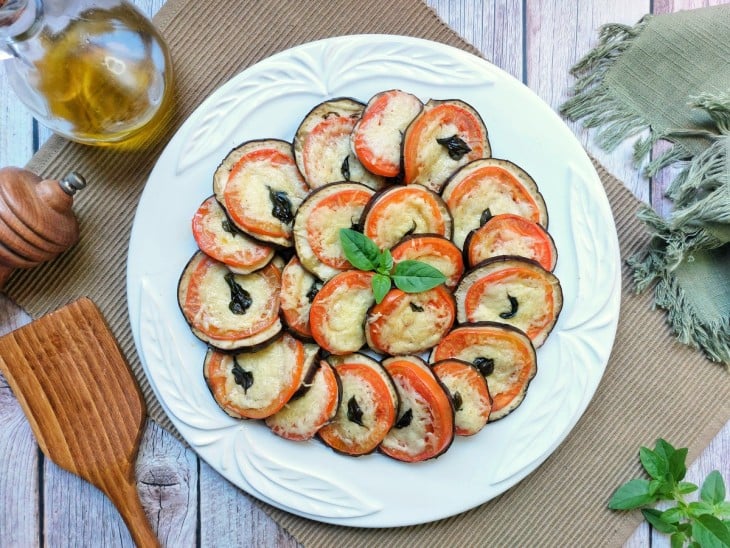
[{"x1": 340, "y1": 228, "x2": 446, "y2": 303}]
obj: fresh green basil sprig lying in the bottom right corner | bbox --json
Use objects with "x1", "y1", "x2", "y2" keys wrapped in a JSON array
[{"x1": 608, "y1": 438, "x2": 730, "y2": 548}]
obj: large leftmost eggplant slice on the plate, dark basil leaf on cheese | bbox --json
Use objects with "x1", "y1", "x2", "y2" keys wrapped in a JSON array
[{"x1": 178, "y1": 251, "x2": 281, "y2": 350}]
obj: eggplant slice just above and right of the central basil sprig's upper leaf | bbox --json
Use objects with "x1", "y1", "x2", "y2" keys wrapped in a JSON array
[{"x1": 361, "y1": 185, "x2": 452, "y2": 249}]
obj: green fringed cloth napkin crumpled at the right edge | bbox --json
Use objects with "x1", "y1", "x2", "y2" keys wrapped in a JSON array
[{"x1": 561, "y1": 5, "x2": 730, "y2": 367}]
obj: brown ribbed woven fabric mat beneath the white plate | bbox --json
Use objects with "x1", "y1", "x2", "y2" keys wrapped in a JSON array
[{"x1": 6, "y1": 0, "x2": 730, "y2": 546}]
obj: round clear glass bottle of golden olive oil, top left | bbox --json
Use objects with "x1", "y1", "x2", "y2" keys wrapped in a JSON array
[{"x1": 0, "y1": 0, "x2": 172, "y2": 145}]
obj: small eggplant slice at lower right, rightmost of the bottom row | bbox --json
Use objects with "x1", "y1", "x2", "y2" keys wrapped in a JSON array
[{"x1": 431, "y1": 358, "x2": 492, "y2": 436}]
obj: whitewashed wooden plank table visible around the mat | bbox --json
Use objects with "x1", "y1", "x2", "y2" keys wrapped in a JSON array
[{"x1": 0, "y1": 0, "x2": 730, "y2": 547}]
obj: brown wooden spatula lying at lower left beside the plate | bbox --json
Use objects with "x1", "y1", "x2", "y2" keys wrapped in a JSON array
[{"x1": 0, "y1": 298, "x2": 158, "y2": 547}]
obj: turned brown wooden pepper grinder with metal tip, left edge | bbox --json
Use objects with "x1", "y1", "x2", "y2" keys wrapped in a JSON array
[{"x1": 0, "y1": 167, "x2": 86, "y2": 288}]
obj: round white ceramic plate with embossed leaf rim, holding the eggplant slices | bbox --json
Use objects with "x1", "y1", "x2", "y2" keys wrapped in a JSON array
[{"x1": 127, "y1": 35, "x2": 620, "y2": 527}]
